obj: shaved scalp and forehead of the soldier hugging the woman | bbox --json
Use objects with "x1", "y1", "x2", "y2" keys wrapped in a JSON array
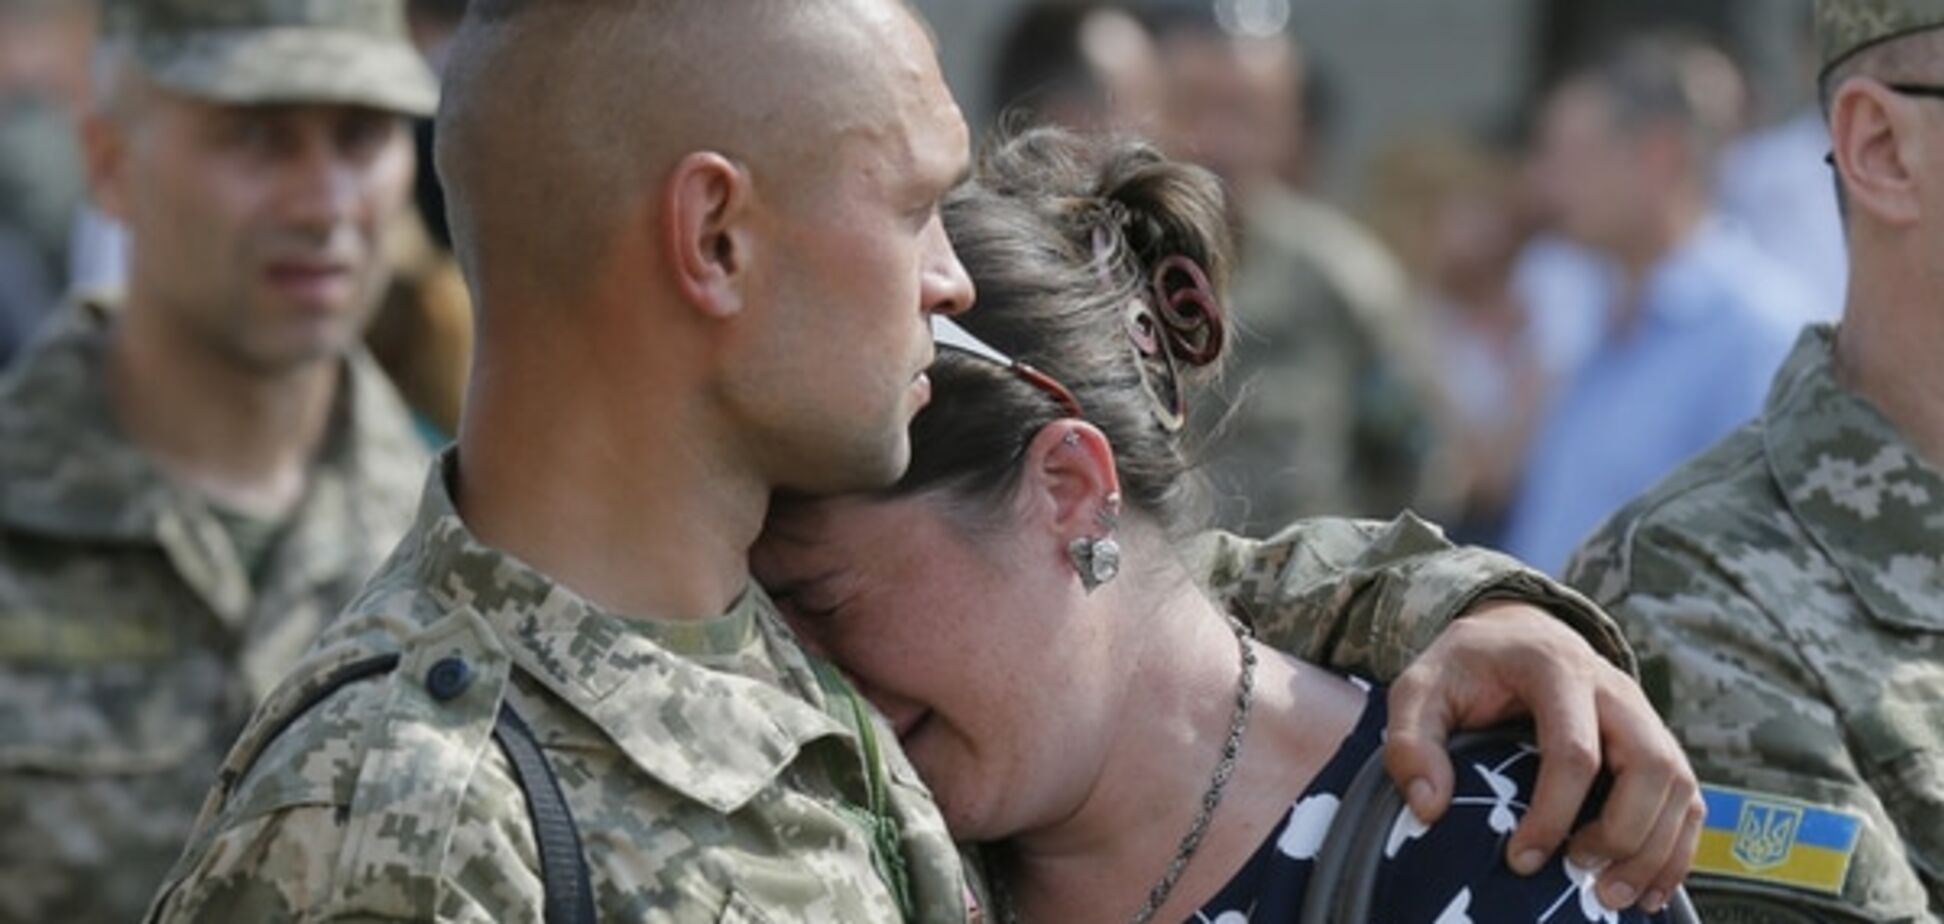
[{"x1": 437, "y1": 0, "x2": 956, "y2": 311}]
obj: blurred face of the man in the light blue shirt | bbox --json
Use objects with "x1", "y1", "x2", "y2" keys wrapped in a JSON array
[{"x1": 1532, "y1": 80, "x2": 1658, "y2": 251}]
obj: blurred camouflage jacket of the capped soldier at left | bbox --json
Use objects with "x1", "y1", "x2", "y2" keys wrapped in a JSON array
[{"x1": 0, "y1": 305, "x2": 426, "y2": 922}]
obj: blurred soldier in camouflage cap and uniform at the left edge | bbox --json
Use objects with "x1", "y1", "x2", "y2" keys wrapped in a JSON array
[{"x1": 0, "y1": 0, "x2": 435, "y2": 922}]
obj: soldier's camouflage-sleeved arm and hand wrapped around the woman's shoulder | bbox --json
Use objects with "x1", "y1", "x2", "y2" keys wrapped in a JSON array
[{"x1": 1207, "y1": 515, "x2": 1699, "y2": 906}]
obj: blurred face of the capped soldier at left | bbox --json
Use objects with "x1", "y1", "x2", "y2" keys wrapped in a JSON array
[{"x1": 89, "y1": 80, "x2": 414, "y2": 373}]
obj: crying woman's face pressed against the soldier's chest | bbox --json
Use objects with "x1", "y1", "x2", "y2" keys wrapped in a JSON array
[{"x1": 750, "y1": 496, "x2": 1118, "y2": 840}]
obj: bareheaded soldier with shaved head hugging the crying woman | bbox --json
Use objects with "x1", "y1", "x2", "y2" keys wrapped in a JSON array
[{"x1": 152, "y1": 0, "x2": 1684, "y2": 922}]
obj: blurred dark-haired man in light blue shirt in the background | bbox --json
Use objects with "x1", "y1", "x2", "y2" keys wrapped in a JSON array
[{"x1": 1505, "y1": 35, "x2": 1810, "y2": 574}]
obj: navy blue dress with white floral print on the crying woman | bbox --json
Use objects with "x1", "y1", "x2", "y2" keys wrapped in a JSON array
[{"x1": 1188, "y1": 689, "x2": 1666, "y2": 924}]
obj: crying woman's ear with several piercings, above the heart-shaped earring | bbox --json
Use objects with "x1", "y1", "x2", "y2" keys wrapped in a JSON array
[{"x1": 1021, "y1": 418, "x2": 1120, "y2": 549}]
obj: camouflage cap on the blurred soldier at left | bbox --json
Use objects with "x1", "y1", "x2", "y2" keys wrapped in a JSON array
[{"x1": 105, "y1": 0, "x2": 439, "y2": 115}]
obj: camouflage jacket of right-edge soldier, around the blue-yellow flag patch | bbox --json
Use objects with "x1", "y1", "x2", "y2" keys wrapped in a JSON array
[{"x1": 1571, "y1": 327, "x2": 1944, "y2": 922}]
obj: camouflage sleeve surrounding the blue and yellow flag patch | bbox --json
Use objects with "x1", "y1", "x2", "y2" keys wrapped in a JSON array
[{"x1": 1571, "y1": 527, "x2": 1927, "y2": 920}]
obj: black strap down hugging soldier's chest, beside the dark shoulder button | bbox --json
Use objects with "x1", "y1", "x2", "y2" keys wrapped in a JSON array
[{"x1": 492, "y1": 700, "x2": 595, "y2": 924}]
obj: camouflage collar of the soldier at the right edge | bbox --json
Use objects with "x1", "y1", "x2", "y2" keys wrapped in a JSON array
[{"x1": 1763, "y1": 325, "x2": 1944, "y2": 632}]
